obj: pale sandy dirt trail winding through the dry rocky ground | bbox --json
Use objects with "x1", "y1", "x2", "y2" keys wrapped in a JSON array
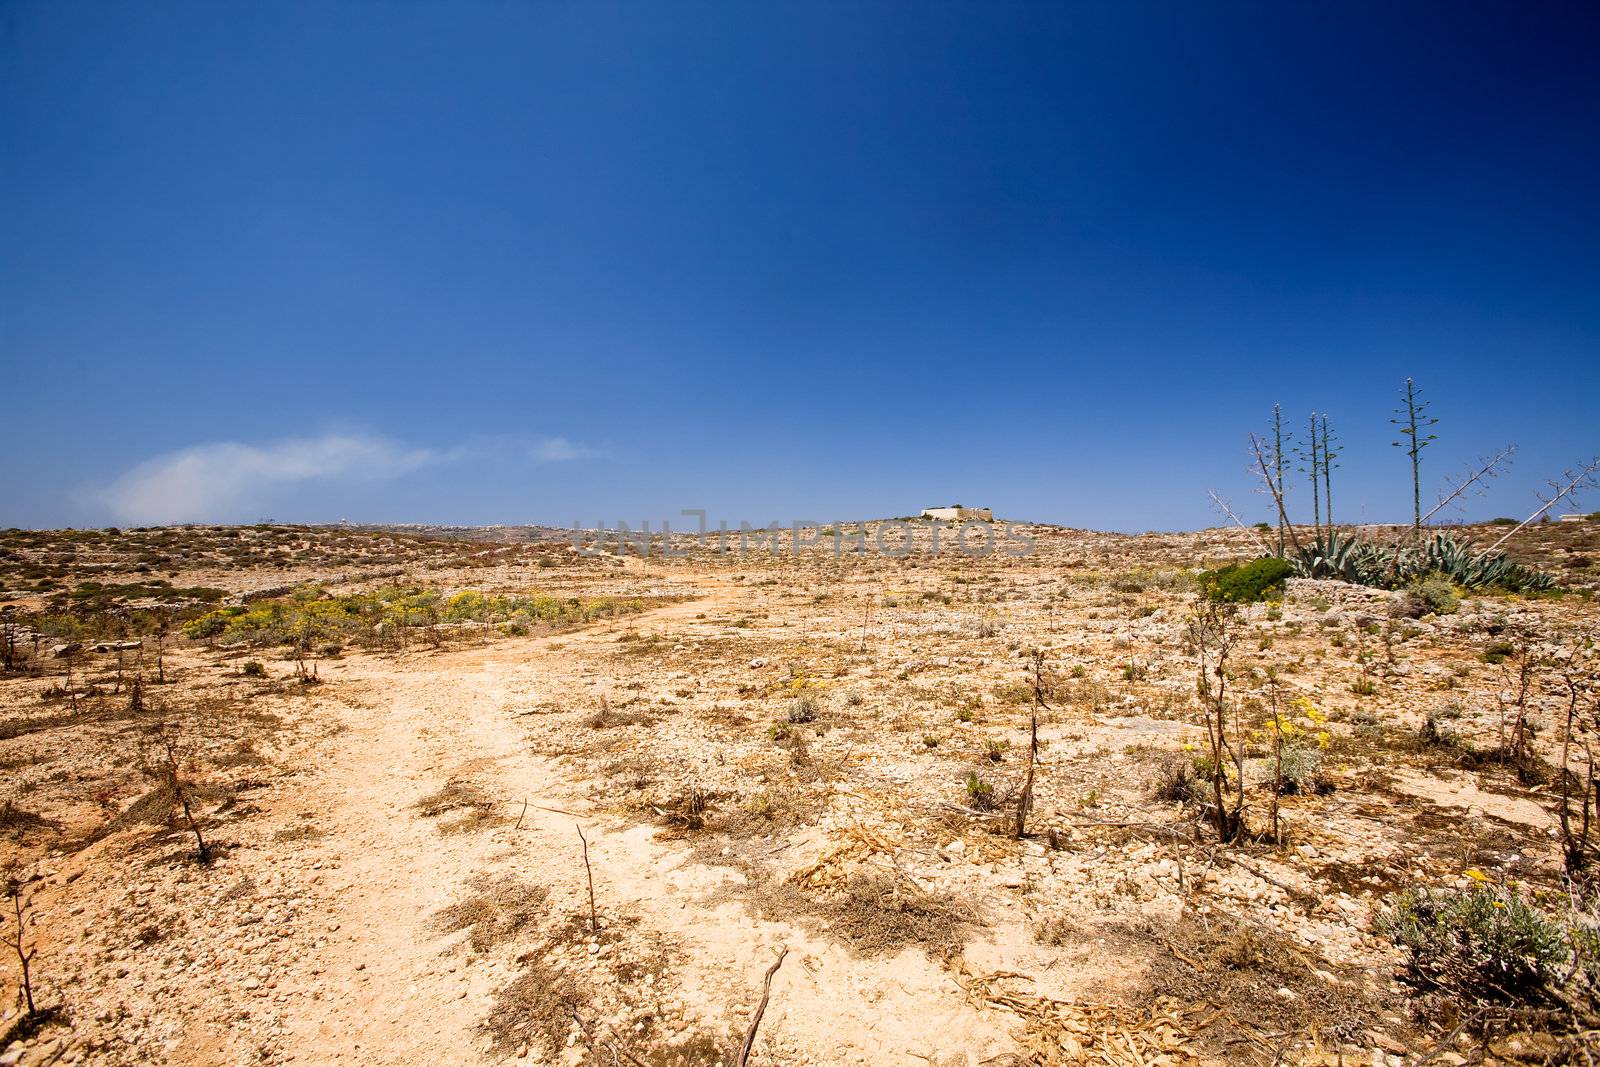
[{"x1": 241, "y1": 582, "x2": 1014, "y2": 1064}]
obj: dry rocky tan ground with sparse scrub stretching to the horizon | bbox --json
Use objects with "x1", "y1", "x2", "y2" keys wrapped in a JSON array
[{"x1": 0, "y1": 523, "x2": 1600, "y2": 1067}]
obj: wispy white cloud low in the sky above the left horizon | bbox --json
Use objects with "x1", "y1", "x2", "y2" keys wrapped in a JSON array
[{"x1": 91, "y1": 434, "x2": 595, "y2": 525}]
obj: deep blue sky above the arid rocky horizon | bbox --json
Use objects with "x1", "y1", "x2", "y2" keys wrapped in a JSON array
[{"x1": 0, "y1": 0, "x2": 1600, "y2": 530}]
